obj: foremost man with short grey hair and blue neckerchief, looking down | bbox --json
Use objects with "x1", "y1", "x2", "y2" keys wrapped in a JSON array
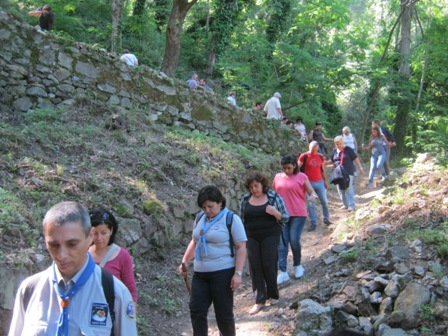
[{"x1": 8, "y1": 202, "x2": 137, "y2": 336}]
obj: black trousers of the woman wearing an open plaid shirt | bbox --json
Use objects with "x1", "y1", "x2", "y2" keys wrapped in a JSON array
[{"x1": 247, "y1": 235, "x2": 280, "y2": 304}]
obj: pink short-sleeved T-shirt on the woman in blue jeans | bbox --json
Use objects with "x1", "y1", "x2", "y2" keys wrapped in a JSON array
[{"x1": 272, "y1": 173, "x2": 308, "y2": 217}]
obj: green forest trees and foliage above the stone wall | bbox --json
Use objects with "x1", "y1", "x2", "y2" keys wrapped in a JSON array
[{"x1": 5, "y1": 0, "x2": 448, "y2": 164}]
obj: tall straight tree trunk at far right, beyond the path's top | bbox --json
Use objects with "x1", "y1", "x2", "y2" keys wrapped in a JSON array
[{"x1": 394, "y1": 0, "x2": 416, "y2": 154}]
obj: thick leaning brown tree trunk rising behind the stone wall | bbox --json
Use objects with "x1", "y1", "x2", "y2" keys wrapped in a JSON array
[{"x1": 161, "y1": 0, "x2": 198, "y2": 77}]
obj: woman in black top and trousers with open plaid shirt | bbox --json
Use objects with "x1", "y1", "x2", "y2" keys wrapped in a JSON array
[{"x1": 240, "y1": 171, "x2": 289, "y2": 315}]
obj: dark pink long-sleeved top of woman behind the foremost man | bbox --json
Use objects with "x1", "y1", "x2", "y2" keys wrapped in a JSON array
[{"x1": 99, "y1": 247, "x2": 137, "y2": 302}]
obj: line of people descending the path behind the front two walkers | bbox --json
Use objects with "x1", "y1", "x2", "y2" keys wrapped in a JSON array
[{"x1": 179, "y1": 117, "x2": 394, "y2": 336}]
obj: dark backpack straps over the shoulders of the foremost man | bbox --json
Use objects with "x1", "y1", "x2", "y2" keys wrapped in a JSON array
[{"x1": 23, "y1": 268, "x2": 115, "y2": 336}]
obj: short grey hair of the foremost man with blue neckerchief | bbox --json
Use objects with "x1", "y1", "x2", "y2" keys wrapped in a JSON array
[{"x1": 42, "y1": 202, "x2": 92, "y2": 237}]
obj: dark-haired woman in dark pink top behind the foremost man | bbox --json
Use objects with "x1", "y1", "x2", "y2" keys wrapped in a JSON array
[{"x1": 89, "y1": 209, "x2": 137, "y2": 302}]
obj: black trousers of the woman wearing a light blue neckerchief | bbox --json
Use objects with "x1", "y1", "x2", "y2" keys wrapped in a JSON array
[{"x1": 190, "y1": 268, "x2": 235, "y2": 336}]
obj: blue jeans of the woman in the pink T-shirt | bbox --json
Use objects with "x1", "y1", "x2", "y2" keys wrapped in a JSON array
[{"x1": 278, "y1": 216, "x2": 306, "y2": 272}]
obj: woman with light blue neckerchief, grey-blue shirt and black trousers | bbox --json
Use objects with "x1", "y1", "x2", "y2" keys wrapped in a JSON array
[{"x1": 179, "y1": 185, "x2": 247, "y2": 336}]
